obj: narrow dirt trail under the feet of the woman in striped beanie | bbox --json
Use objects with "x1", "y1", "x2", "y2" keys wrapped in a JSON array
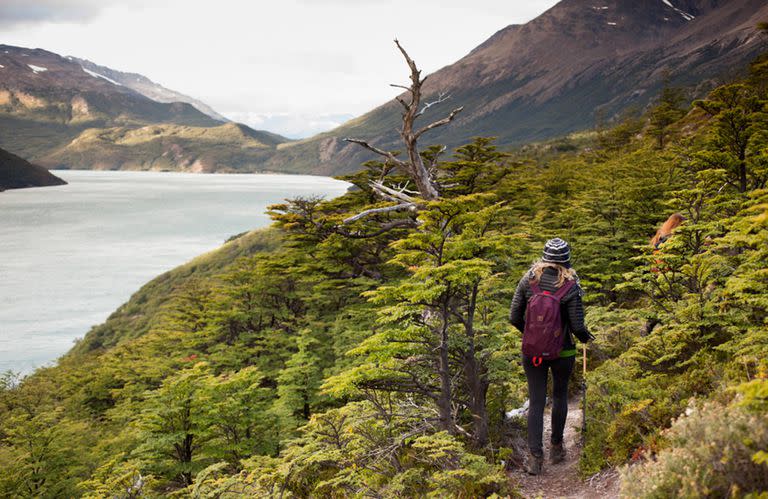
[{"x1": 509, "y1": 399, "x2": 619, "y2": 499}]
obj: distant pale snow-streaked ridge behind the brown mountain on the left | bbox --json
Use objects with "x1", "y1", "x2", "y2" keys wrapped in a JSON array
[{"x1": 68, "y1": 56, "x2": 229, "y2": 122}]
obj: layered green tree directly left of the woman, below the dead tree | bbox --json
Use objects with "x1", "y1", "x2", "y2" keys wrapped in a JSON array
[{"x1": 326, "y1": 194, "x2": 515, "y2": 446}]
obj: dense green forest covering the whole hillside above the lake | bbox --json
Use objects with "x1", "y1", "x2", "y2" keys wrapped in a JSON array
[{"x1": 0, "y1": 48, "x2": 768, "y2": 498}]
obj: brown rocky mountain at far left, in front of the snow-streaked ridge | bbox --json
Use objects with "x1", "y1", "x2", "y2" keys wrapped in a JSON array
[{"x1": 0, "y1": 45, "x2": 221, "y2": 160}]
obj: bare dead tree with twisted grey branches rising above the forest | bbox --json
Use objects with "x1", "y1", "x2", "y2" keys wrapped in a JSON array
[{"x1": 344, "y1": 39, "x2": 463, "y2": 204}]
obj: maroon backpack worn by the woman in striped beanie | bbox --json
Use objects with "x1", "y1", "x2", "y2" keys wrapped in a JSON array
[{"x1": 523, "y1": 280, "x2": 574, "y2": 367}]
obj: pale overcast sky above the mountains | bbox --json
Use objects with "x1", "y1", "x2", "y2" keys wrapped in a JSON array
[{"x1": 0, "y1": 0, "x2": 557, "y2": 138}]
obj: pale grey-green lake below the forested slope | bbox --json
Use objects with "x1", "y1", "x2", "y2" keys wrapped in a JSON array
[{"x1": 0, "y1": 170, "x2": 349, "y2": 373}]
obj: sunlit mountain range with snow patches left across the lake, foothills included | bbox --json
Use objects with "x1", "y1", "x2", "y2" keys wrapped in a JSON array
[{"x1": 0, "y1": 45, "x2": 288, "y2": 172}]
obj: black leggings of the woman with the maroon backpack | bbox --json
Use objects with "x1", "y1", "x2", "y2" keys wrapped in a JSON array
[{"x1": 523, "y1": 356, "x2": 576, "y2": 456}]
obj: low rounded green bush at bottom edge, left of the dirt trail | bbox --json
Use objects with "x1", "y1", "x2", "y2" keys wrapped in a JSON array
[{"x1": 231, "y1": 399, "x2": 510, "y2": 497}]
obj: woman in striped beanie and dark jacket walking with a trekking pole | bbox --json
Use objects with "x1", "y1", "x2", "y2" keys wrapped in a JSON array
[{"x1": 510, "y1": 238, "x2": 594, "y2": 475}]
